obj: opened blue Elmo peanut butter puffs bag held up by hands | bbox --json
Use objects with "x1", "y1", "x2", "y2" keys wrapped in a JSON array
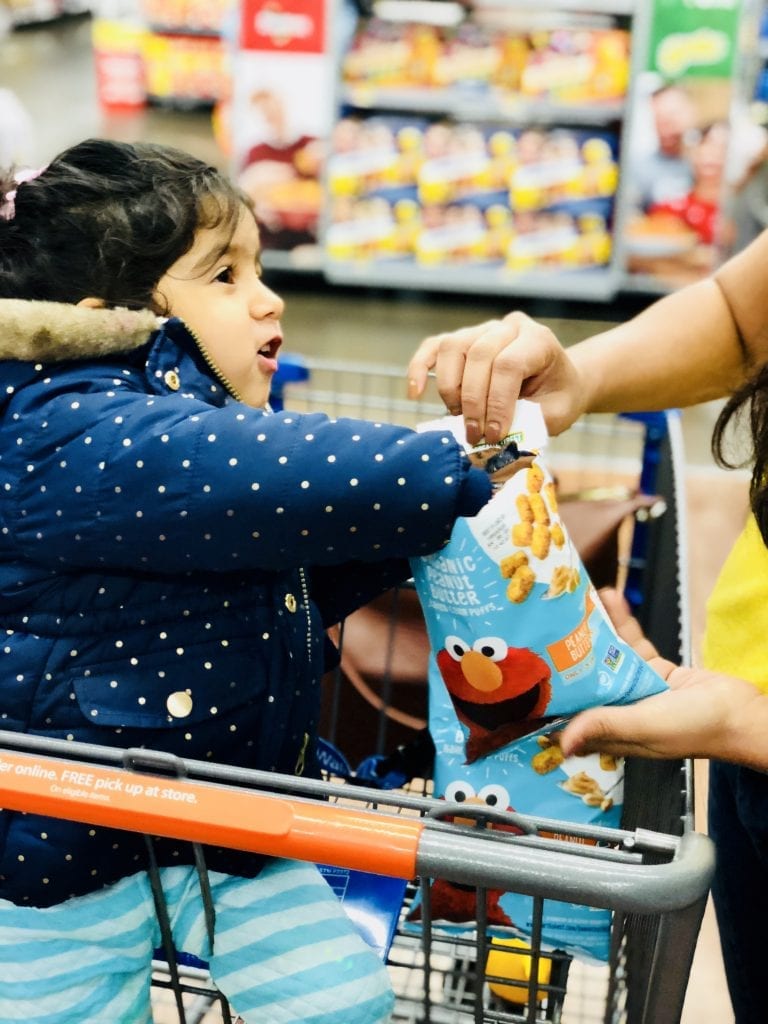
[{"x1": 411, "y1": 401, "x2": 666, "y2": 764}]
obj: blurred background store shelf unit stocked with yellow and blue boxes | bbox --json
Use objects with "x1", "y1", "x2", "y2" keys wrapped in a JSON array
[{"x1": 323, "y1": 0, "x2": 635, "y2": 301}]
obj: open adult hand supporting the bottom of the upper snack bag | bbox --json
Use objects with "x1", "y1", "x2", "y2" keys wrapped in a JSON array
[{"x1": 560, "y1": 592, "x2": 768, "y2": 770}]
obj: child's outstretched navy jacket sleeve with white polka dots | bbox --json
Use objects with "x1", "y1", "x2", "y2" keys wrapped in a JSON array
[{"x1": 0, "y1": 380, "x2": 490, "y2": 572}]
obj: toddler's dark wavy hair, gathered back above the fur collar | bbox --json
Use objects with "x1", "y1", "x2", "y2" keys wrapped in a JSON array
[{"x1": 0, "y1": 139, "x2": 250, "y2": 313}]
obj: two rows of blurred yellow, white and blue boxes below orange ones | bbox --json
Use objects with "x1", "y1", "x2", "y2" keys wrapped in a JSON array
[{"x1": 326, "y1": 115, "x2": 618, "y2": 271}]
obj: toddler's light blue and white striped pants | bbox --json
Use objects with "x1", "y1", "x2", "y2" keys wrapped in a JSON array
[{"x1": 0, "y1": 860, "x2": 393, "y2": 1024}]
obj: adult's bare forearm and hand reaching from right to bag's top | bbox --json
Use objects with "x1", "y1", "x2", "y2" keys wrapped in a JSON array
[{"x1": 408, "y1": 230, "x2": 768, "y2": 442}]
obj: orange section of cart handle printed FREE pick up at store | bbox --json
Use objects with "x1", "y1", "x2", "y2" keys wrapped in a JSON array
[{"x1": 0, "y1": 749, "x2": 424, "y2": 879}]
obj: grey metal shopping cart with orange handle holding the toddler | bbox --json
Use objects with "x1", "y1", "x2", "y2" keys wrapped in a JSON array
[{"x1": 0, "y1": 360, "x2": 713, "y2": 1024}]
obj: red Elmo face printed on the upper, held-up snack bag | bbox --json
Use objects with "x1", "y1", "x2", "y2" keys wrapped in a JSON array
[{"x1": 436, "y1": 636, "x2": 552, "y2": 763}]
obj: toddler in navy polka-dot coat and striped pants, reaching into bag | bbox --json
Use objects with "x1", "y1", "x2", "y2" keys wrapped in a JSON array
[{"x1": 0, "y1": 139, "x2": 490, "y2": 1024}]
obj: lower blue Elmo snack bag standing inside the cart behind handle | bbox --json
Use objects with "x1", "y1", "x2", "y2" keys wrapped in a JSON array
[{"x1": 403, "y1": 704, "x2": 624, "y2": 963}]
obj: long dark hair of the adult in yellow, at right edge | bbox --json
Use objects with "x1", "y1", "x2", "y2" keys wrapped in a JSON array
[{"x1": 712, "y1": 365, "x2": 768, "y2": 545}]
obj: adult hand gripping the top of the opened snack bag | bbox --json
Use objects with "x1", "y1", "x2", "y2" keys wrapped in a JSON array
[{"x1": 408, "y1": 311, "x2": 584, "y2": 444}]
